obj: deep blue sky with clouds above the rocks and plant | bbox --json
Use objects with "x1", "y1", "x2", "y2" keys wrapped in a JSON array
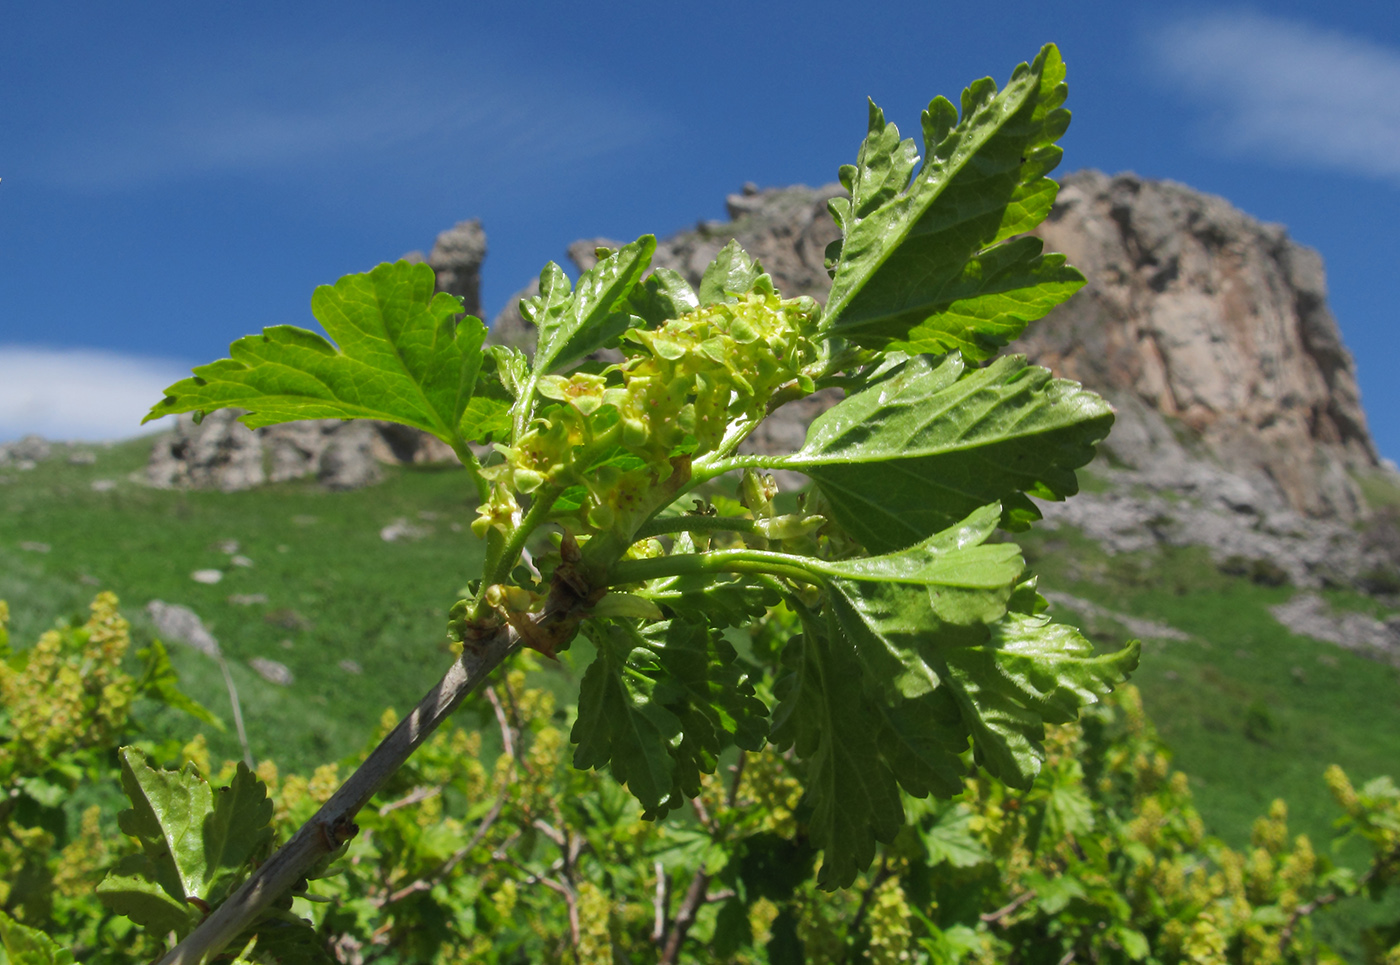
[{"x1": 0, "y1": 0, "x2": 1400, "y2": 458}]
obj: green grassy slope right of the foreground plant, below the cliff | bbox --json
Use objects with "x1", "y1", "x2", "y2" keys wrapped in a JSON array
[{"x1": 1016, "y1": 529, "x2": 1400, "y2": 958}]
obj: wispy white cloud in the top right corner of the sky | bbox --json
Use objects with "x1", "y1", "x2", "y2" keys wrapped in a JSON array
[{"x1": 1148, "y1": 11, "x2": 1400, "y2": 181}]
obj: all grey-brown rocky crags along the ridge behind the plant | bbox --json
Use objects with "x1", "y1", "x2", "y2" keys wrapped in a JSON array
[{"x1": 151, "y1": 171, "x2": 1400, "y2": 585}]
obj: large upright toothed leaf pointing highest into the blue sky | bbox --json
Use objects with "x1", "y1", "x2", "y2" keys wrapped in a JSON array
[{"x1": 823, "y1": 45, "x2": 1084, "y2": 359}]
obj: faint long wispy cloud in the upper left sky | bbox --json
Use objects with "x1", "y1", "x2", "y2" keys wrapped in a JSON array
[{"x1": 35, "y1": 45, "x2": 669, "y2": 189}]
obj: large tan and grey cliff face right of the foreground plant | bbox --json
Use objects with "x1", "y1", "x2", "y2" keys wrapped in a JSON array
[{"x1": 1016, "y1": 171, "x2": 1379, "y2": 521}]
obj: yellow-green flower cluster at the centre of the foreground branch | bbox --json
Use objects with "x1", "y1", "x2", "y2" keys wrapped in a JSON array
[{"x1": 487, "y1": 293, "x2": 818, "y2": 529}]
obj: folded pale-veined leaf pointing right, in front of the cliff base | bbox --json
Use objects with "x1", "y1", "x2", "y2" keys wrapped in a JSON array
[{"x1": 746, "y1": 354, "x2": 1113, "y2": 552}]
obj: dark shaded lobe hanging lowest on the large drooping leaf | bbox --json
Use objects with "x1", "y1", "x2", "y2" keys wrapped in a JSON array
[{"x1": 771, "y1": 613, "x2": 904, "y2": 889}]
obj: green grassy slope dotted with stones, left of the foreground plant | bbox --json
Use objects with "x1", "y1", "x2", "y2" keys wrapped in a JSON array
[{"x1": 0, "y1": 438, "x2": 480, "y2": 769}]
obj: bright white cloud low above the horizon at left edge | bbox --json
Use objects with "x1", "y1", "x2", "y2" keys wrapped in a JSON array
[{"x1": 0, "y1": 345, "x2": 189, "y2": 443}]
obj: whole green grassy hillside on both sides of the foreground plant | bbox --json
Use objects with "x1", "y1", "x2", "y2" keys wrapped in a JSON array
[{"x1": 0, "y1": 440, "x2": 1400, "y2": 946}]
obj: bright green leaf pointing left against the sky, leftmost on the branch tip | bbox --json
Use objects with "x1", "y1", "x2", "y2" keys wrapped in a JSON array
[{"x1": 146, "y1": 262, "x2": 486, "y2": 450}]
